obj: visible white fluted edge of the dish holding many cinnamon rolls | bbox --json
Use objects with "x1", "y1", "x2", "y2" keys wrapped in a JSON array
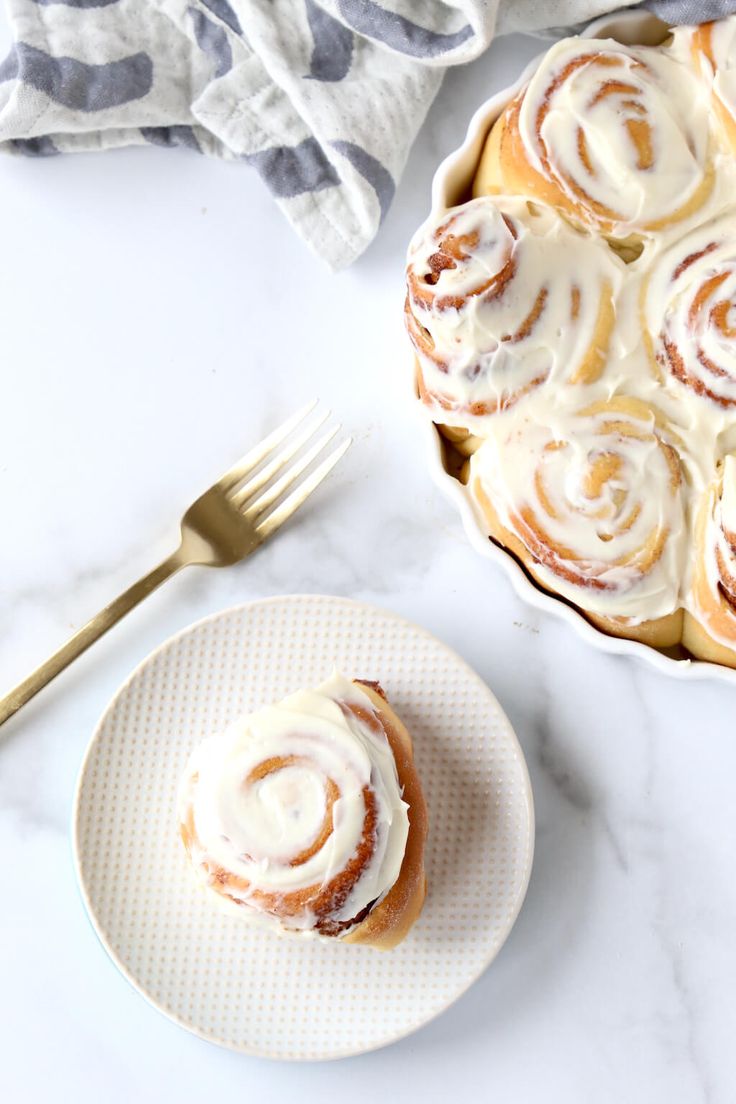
[{"x1": 412, "y1": 12, "x2": 736, "y2": 684}]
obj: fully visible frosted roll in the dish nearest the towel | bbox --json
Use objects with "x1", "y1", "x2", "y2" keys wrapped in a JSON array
[{"x1": 473, "y1": 39, "x2": 713, "y2": 238}]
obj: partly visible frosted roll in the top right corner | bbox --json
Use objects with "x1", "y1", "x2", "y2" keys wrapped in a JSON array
[{"x1": 674, "y1": 15, "x2": 736, "y2": 152}]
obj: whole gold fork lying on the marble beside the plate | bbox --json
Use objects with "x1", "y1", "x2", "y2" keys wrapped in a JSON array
[{"x1": 0, "y1": 402, "x2": 351, "y2": 724}]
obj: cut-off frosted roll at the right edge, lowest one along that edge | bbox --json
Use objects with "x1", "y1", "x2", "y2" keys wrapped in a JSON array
[{"x1": 682, "y1": 454, "x2": 736, "y2": 667}]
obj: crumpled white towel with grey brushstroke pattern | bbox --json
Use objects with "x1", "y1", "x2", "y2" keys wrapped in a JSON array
[{"x1": 0, "y1": 0, "x2": 736, "y2": 268}]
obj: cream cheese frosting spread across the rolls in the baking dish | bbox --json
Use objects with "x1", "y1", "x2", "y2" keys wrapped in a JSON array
[{"x1": 408, "y1": 23, "x2": 736, "y2": 648}]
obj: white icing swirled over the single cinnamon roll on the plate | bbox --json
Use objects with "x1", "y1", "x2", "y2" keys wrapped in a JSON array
[{"x1": 179, "y1": 672, "x2": 408, "y2": 932}]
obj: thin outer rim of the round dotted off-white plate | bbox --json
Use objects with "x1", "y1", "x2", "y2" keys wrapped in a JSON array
[{"x1": 71, "y1": 592, "x2": 536, "y2": 1063}]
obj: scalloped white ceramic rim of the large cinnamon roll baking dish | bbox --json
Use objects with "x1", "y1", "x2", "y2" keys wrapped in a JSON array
[{"x1": 407, "y1": 10, "x2": 736, "y2": 686}]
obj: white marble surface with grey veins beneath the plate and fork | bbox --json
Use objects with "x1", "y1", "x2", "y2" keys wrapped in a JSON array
[{"x1": 0, "y1": 19, "x2": 736, "y2": 1104}]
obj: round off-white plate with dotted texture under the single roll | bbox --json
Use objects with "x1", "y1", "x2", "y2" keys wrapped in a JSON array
[{"x1": 74, "y1": 595, "x2": 534, "y2": 1059}]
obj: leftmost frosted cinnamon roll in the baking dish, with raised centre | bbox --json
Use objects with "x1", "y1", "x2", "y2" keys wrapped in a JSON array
[{"x1": 405, "y1": 195, "x2": 623, "y2": 426}]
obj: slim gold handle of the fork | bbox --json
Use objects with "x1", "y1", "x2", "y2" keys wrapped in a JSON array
[{"x1": 0, "y1": 549, "x2": 186, "y2": 724}]
